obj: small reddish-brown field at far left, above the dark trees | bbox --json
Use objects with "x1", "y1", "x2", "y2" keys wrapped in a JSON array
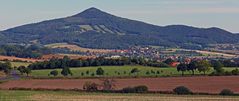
[{"x1": 0, "y1": 55, "x2": 42, "y2": 62}]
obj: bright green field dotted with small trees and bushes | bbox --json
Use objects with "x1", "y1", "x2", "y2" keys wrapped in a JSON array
[{"x1": 31, "y1": 66, "x2": 237, "y2": 77}]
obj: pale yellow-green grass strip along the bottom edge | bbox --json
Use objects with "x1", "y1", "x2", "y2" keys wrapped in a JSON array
[{"x1": 0, "y1": 90, "x2": 239, "y2": 101}]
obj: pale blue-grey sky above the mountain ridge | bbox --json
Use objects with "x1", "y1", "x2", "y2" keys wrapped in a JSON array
[{"x1": 0, "y1": 0, "x2": 239, "y2": 33}]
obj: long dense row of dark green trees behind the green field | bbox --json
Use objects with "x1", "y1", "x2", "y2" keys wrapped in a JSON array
[{"x1": 29, "y1": 56, "x2": 169, "y2": 70}]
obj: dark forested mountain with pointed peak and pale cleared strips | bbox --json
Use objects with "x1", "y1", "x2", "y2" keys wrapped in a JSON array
[{"x1": 0, "y1": 8, "x2": 239, "y2": 49}]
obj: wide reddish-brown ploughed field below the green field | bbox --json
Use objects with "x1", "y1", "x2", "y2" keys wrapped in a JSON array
[{"x1": 0, "y1": 76, "x2": 239, "y2": 94}]
